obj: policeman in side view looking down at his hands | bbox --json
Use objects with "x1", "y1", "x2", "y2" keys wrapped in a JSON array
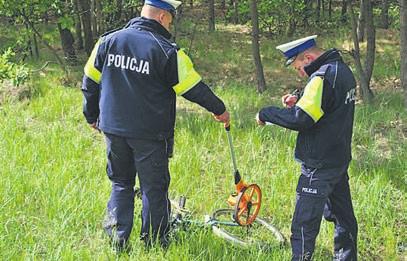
[{"x1": 256, "y1": 35, "x2": 358, "y2": 260}]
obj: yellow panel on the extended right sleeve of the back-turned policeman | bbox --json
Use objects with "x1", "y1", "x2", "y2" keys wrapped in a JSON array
[{"x1": 173, "y1": 50, "x2": 202, "y2": 95}]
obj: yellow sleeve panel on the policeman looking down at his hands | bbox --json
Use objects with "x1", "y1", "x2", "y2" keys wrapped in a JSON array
[{"x1": 296, "y1": 76, "x2": 324, "y2": 122}]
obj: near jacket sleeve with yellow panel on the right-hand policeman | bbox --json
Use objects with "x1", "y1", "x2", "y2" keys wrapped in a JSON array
[{"x1": 259, "y1": 76, "x2": 332, "y2": 131}]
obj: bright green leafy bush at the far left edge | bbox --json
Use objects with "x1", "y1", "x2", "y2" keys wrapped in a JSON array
[{"x1": 0, "y1": 48, "x2": 30, "y2": 86}]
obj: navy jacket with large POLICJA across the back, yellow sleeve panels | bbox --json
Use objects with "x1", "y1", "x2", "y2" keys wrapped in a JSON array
[{"x1": 82, "y1": 17, "x2": 226, "y2": 140}]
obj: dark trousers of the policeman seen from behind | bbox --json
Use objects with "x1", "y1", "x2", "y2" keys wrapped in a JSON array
[{"x1": 104, "y1": 133, "x2": 171, "y2": 245}]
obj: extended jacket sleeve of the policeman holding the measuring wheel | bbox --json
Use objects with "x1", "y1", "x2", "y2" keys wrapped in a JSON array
[{"x1": 165, "y1": 50, "x2": 226, "y2": 115}]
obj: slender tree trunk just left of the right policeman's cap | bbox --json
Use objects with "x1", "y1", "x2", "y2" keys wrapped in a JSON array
[{"x1": 250, "y1": 0, "x2": 266, "y2": 93}]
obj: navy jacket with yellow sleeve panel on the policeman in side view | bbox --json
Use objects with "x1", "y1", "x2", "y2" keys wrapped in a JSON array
[{"x1": 259, "y1": 49, "x2": 356, "y2": 168}]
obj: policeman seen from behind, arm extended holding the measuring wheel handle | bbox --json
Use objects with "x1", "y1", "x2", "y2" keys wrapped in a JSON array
[{"x1": 82, "y1": 0, "x2": 229, "y2": 247}]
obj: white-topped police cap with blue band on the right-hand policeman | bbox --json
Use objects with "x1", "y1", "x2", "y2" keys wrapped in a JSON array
[{"x1": 276, "y1": 35, "x2": 318, "y2": 66}]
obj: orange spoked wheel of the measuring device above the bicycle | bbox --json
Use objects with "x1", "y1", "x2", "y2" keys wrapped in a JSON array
[{"x1": 233, "y1": 184, "x2": 261, "y2": 226}]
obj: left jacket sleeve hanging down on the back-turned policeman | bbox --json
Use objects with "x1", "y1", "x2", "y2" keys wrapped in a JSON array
[{"x1": 82, "y1": 40, "x2": 104, "y2": 124}]
